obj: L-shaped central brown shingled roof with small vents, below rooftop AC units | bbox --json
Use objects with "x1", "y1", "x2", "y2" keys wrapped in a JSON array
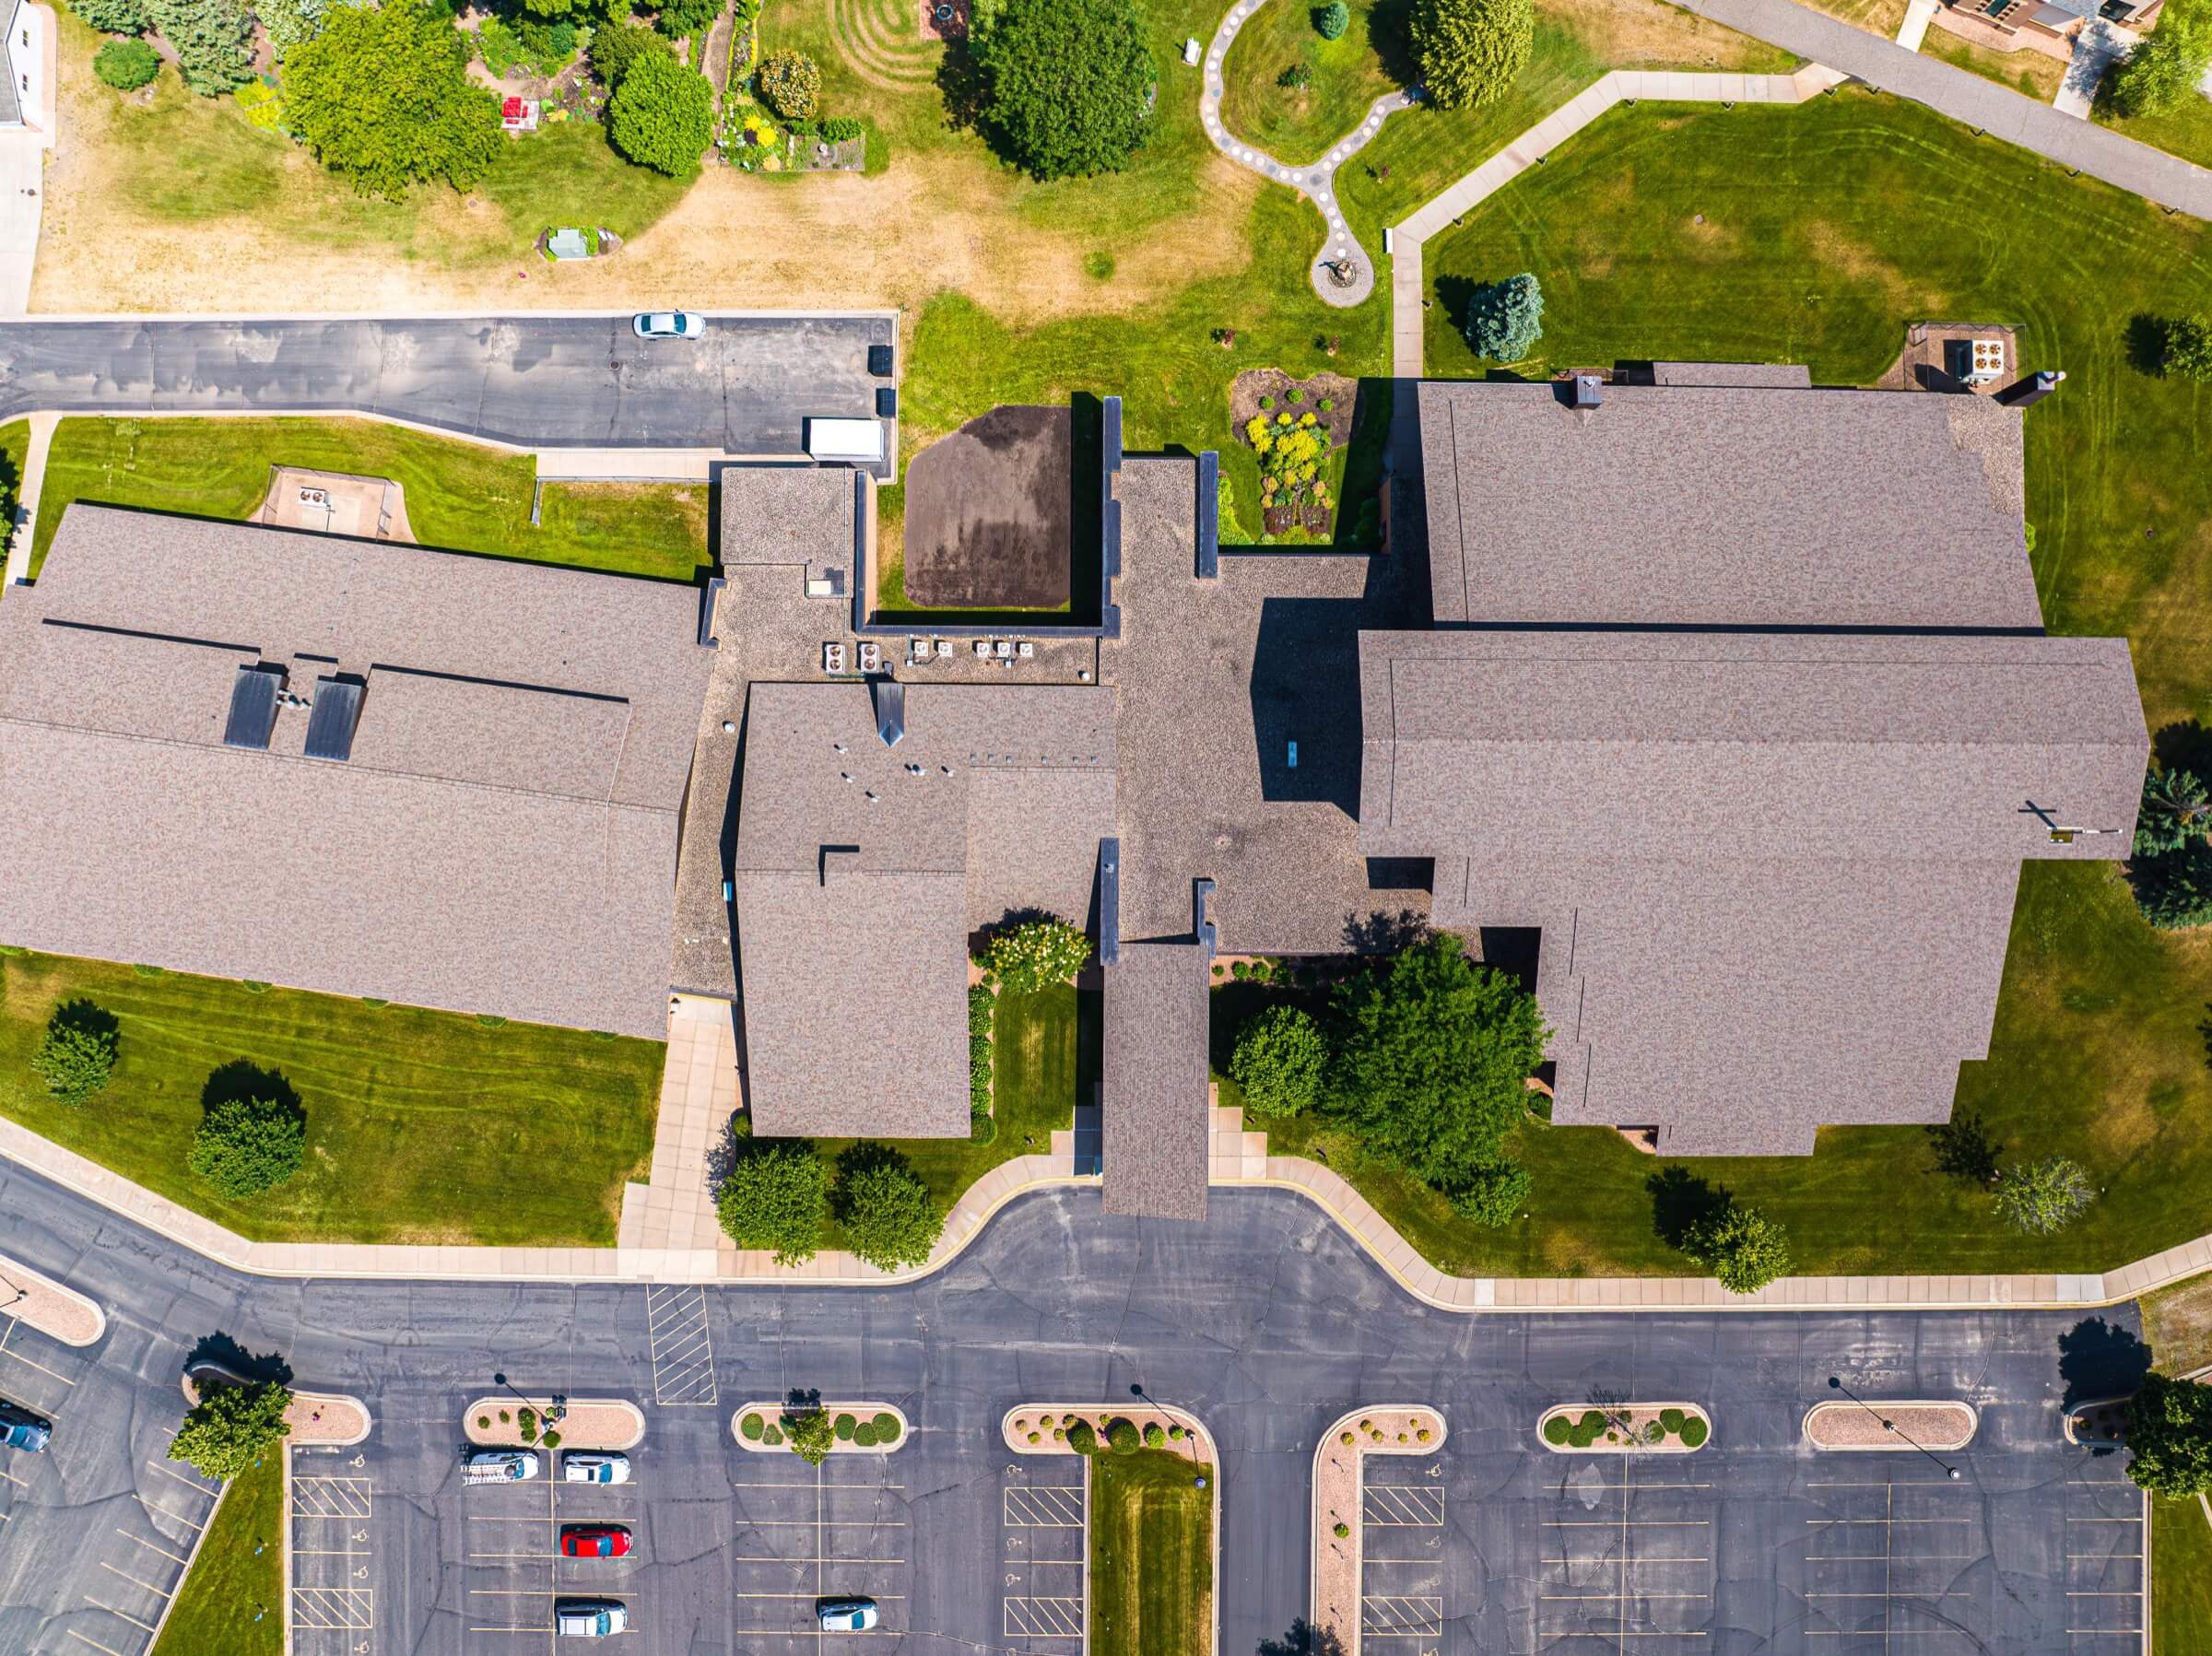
[{"x1": 732, "y1": 683, "x2": 1117, "y2": 1139}]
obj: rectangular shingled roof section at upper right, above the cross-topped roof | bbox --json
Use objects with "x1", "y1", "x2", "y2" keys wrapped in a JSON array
[{"x1": 1420, "y1": 381, "x2": 2041, "y2": 630}]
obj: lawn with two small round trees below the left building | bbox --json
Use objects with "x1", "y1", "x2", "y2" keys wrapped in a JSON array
[{"x1": 0, "y1": 951, "x2": 662, "y2": 1247}]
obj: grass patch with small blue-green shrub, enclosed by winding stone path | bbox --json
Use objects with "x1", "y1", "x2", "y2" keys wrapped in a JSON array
[{"x1": 1201, "y1": 0, "x2": 1389, "y2": 166}]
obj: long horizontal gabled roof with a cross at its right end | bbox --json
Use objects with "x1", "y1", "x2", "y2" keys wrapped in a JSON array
[{"x1": 1360, "y1": 630, "x2": 2147, "y2": 863}]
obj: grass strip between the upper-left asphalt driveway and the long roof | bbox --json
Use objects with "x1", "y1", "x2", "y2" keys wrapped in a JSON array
[{"x1": 31, "y1": 417, "x2": 708, "y2": 581}]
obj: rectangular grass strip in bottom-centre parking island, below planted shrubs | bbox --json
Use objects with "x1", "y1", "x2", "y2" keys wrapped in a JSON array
[{"x1": 1090, "y1": 1448, "x2": 1215, "y2": 1656}]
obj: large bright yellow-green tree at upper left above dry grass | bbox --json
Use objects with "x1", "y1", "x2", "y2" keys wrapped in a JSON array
[{"x1": 283, "y1": 0, "x2": 500, "y2": 201}]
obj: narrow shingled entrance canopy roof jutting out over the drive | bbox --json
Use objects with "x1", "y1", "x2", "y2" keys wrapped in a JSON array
[{"x1": 1100, "y1": 944, "x2": 1210, "y2": 1218}]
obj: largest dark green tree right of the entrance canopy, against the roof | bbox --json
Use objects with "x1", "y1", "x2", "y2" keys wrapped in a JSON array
[{"x1": 1327, "y1": 931, "x2": 1550, "y2": 1190}]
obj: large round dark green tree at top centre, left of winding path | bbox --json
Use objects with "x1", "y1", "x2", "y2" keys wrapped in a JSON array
[{"x1": 973, "y1": 0, "x2": 1159, "y2": 179}]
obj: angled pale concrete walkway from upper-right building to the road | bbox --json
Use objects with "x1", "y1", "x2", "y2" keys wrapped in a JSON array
[{"x1": 1392, "y1": 65, "x2": 1849, "y2": 373}]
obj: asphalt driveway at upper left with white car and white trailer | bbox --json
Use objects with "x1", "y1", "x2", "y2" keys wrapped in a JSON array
[{"x1": 0, "y1": 311, "x2": 896, "y2": 453}]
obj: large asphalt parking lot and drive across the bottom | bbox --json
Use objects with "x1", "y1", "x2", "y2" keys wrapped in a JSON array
[{"x1": 0, "y1": 1168, "x2": 2144, "y2": 1656}]
